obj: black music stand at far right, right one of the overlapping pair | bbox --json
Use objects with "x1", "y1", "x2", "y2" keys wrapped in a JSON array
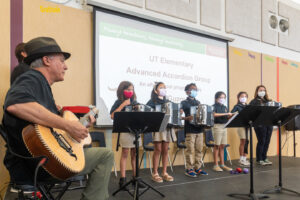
[{"x1": 262, "y1": 108, "x2": 300, "y2": 196}]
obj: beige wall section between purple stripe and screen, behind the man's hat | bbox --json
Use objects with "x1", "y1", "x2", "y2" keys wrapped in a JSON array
[{"x1": 23, "y1": 0, "x2": 93, "y2": 105}]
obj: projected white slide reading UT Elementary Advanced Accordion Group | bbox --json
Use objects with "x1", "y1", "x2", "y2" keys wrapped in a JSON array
[{"x1": 95, "y1": 12, "x2": 227, "y2": 125}]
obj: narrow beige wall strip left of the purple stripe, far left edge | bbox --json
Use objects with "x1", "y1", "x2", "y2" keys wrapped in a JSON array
[{"x1": 0, "y1": 0, "x2": 10, "y2": 196}]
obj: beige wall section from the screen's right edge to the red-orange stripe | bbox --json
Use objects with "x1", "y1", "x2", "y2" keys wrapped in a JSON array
[{"x1": 228, "y1": 47, "x2": 277, "y2": 158}]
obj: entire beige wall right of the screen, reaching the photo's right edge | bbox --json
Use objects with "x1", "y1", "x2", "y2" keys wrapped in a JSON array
[{"x1": 228, "y1": 47, "x2": 300, "y2": 158}]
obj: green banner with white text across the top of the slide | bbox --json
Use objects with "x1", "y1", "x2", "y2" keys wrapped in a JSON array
[{"x1": 100, "y1": 22, "x2": 206, "y2": 54}]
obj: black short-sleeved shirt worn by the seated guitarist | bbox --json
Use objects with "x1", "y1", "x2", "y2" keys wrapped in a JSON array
[{"x1": 2, "y1": 69, "x2": 59, "y2": 184}]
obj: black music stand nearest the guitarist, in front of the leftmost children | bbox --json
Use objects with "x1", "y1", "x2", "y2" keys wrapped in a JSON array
[{"x1": 112, "y1": 112, "x2": 166, "y2": 200}]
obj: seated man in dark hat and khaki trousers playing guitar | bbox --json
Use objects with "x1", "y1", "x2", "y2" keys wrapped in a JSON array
[{"x1": 2, "y1": 37, "x2": 113, "y2": 200}]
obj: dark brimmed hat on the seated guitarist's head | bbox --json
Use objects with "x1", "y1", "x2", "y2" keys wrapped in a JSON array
[{"x1": 24, "y1": 37, "x2": 71, "y2": 65}]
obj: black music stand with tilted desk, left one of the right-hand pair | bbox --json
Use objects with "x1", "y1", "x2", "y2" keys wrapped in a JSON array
[{"x1": 225, "y1": 105, "x2": 278, "y2": 200}]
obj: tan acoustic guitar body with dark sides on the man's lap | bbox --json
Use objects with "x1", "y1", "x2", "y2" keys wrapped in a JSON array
[{"x1": 22, "y1": 111, "x2": 91, "y2": 180}]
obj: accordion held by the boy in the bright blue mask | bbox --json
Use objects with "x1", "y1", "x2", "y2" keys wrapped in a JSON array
[{"x1": 190, "y1": 104, "x2": 214, "y2": 127}]
